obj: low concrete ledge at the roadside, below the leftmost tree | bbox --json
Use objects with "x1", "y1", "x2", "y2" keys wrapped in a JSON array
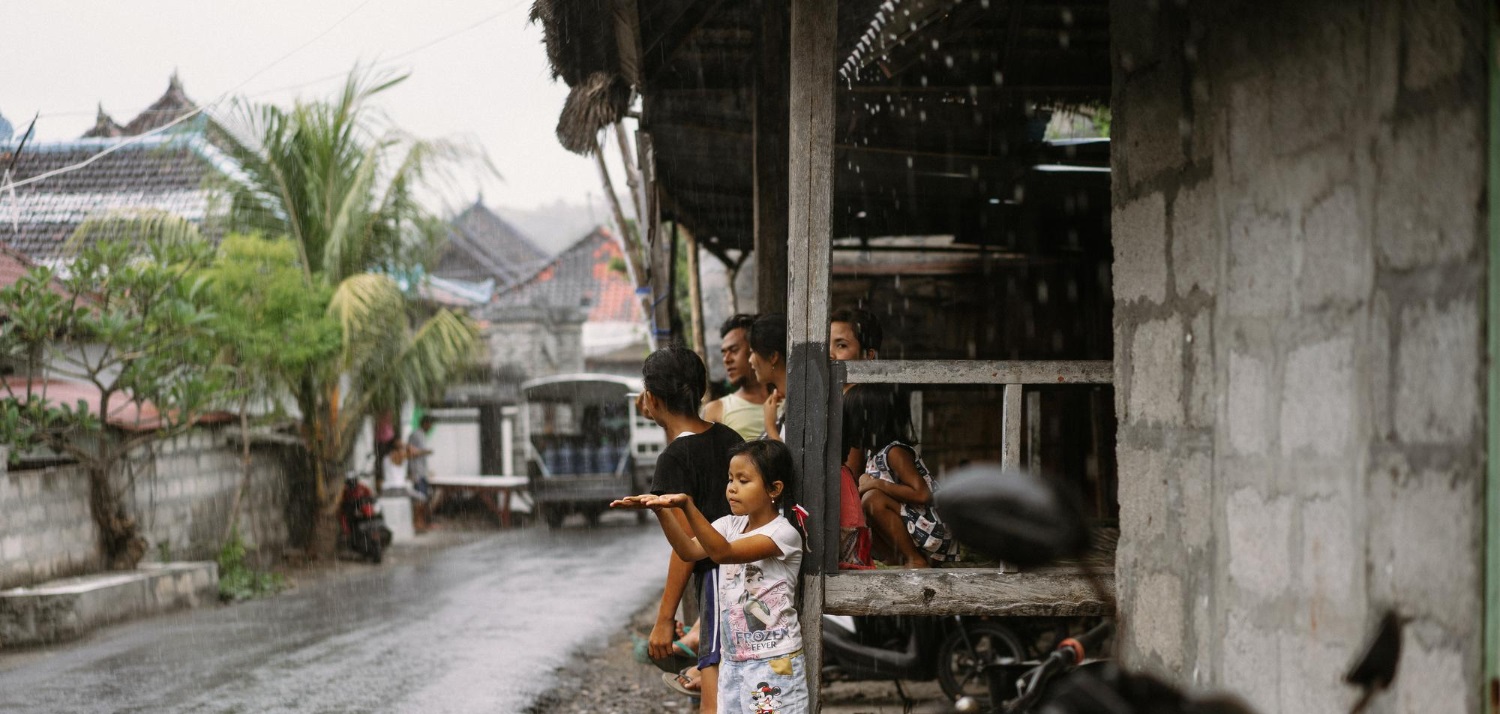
[{"x1": 0, "y1": 563, "x2": 219, "y2": 648}]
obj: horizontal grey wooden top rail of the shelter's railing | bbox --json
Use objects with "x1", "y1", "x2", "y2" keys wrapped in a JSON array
[{"x1": 845, "y1": 360, "x2": 1115, "y2": 384}]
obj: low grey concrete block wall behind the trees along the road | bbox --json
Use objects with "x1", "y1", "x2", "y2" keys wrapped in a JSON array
[{"x1": 0, "y1": 428, "x2": 297, "y2": 590}]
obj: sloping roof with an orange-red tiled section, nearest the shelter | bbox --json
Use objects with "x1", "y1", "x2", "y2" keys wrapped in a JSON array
[{"x1": 495, "y1": 228, "x2": 644, "y2": 323}]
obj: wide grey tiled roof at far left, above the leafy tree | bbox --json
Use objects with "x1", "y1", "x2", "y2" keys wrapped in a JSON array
[{"x1": 0, "y1": 134, "x2": 237, "y2": 261}]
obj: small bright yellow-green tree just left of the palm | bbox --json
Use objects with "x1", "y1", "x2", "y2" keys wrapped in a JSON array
[{"x1": 201, "y1": 234, "x2": 342, "y2": 543}]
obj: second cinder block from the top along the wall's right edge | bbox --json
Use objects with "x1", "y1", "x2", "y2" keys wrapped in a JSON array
[{"x1": 1374, "y1": 108, "x2": 1485, "y2": 269}]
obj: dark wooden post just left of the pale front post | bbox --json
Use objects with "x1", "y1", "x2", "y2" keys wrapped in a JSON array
[{"x1": 752, "y1": 0, "x2": 792, "y2": 315}]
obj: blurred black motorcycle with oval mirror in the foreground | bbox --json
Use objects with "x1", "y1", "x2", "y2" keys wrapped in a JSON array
[{"x1": 936, "y1": 467, "x2": 1403, "y2": 714}]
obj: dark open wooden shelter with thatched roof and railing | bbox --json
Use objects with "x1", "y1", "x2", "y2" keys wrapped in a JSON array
[{"x1": 533, "y1": 0, "x2": 1115, "y2": 696}]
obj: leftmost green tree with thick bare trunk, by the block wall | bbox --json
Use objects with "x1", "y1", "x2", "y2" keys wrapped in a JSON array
[{"x1": 0, "y1": 212, "x2": 225, "y2": 569}]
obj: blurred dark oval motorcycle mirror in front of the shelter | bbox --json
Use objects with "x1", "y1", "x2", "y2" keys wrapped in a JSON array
[{"x1": 935, "y1": 464, "x2": 1089, "y2": 567}]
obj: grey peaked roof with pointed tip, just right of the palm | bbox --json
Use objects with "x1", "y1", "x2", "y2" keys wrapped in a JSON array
[{"x1": 432, "y1": 201, "x2": 548, "y2": 287}]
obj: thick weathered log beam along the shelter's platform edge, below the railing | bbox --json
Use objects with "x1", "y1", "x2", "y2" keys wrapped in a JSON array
[{"x1": 822, "y1": 569, "x2": 1115, "y2": 617}]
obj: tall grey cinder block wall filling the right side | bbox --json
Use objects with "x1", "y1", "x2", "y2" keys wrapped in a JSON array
[{"x1": 1110, "y1": 0, "x2": 1487, "y2": 713}]
